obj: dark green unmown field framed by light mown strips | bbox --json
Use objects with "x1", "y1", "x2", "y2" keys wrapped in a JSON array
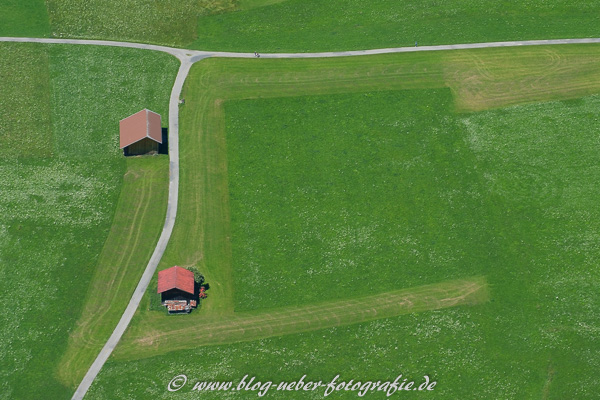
[{"x1": 225, "y1": 89, "x2": 488, "y2": 311}]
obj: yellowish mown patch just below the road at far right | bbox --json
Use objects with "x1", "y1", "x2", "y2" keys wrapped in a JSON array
[{"x1": 445, "y1": 45, "x2": 600, "y2": 111}]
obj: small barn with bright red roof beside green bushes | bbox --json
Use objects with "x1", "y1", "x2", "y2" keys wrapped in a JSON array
[{"x1": 158, "y1": 266, "x2": 198, "y2": 314}]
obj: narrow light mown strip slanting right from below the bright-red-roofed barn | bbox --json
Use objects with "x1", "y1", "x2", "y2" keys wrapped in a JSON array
[{"x1": 114, "y1": 277, "x2": 489, "y2": 359}]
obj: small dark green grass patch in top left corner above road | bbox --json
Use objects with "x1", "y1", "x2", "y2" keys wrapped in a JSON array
[{"x1": 0, "y1": 0, "x2": 50, "y2": 37}]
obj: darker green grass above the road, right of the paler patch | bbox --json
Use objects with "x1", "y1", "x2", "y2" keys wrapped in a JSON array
[{"x1": 187, "y1": 0, "x2": 600, "y2": 52}]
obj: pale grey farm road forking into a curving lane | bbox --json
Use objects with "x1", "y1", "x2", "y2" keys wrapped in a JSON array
[{"x1": 0, "y1": 37, "x2": 600, "y2": 400}]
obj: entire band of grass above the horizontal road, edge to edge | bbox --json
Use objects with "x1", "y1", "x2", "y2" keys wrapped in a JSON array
[{"x1": 0, "y1": 0, "x2": 600, "y2": 52}]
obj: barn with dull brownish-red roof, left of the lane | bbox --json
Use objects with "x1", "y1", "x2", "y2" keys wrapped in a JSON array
[{"x1": 119, "y1": 109, "x2": 163, "y2": 156}]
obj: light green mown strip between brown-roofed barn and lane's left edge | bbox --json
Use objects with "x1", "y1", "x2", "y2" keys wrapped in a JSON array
[{"x1": 58, "y1": 156, "x2": 169, "y2": 387}]
